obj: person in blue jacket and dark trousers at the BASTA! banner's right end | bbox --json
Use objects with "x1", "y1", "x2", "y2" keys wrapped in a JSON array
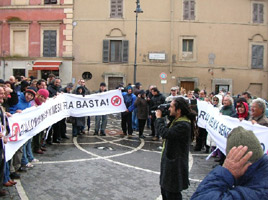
[{"x1": 121, "y1": 85, "x2": 136, "y2": 137}]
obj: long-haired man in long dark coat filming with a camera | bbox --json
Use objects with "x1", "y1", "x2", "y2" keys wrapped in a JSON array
[{"x1": 155, "y1": 97, "x2": 196, "y2": 200}]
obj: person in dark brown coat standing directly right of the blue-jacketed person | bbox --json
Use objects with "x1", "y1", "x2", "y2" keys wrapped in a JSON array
[{"x1": 134, "y1": 90, "x2": 149, "y2": 139}]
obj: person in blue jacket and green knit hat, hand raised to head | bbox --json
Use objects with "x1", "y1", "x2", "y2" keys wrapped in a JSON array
[{"x1": 191, "y1": 126, "x2": 268, "y2": 200}]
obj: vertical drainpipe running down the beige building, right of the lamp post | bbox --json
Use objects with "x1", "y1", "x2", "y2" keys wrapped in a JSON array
[{"x1": 169, "y1": 0, "x2": 174, "y2": 73}]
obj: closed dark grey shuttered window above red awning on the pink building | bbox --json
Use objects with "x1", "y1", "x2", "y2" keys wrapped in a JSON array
[{"x1": 43, "y1": 30, "x2": 57, "y2": 57}]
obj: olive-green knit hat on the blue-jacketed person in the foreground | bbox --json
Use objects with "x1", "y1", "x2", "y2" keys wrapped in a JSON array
[{"x1": 226, "y1": 126, "x2": 264, "y2": 163}]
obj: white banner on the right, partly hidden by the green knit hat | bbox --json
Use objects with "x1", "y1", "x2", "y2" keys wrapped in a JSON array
[{"x1": 197, "y1": 100, "x2": 268, "y2": 154}]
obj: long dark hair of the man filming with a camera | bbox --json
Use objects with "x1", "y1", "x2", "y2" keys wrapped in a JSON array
[{"x1": 173, "y1": 97, "x2": 197, "y2": 141}]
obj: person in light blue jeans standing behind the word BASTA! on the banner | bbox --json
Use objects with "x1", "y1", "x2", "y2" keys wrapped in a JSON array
[{"x1": 94, "y1": 82, "x2": 107, "y2": 136}]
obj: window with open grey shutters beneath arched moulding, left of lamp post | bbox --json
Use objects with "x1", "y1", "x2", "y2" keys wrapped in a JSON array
[{"x1": 102, "y1": 40, "x2": 128, "y2": 63}]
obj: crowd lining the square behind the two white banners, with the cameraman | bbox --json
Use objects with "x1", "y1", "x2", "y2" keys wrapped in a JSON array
[{"x1": 0, "y1": 74, "x2": 268, "y2": 199}]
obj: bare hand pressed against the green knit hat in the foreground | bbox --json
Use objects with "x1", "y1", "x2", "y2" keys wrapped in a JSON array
[{"x1": 223, "y1": 145, "x2": 253, "y2": 179}]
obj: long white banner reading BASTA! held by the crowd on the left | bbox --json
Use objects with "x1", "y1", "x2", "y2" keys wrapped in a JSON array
[{"x1": 5, "y1": 90, "x2": 126, "y2": 160}]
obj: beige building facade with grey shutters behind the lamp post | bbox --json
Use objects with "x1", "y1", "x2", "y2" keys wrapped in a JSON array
[{"x1": 73, "y1": 0, "x2": 268, "y2": 99}]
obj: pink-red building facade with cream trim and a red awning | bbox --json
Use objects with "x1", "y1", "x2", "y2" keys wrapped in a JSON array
[{"x1": 0, "y1": 0, "x2": 73, "y2": 84}]
